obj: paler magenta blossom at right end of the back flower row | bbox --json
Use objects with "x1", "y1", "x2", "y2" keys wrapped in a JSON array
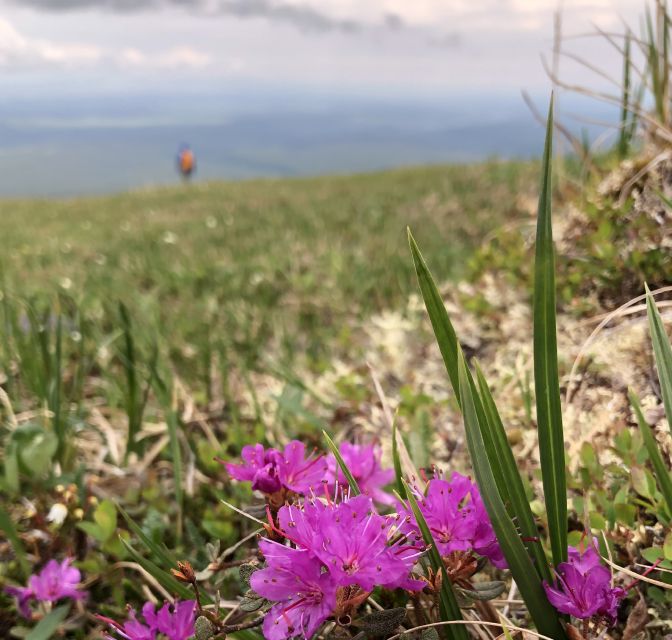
[{"x1": 327, "y1": 442, "x2": 394, "y2": 504}]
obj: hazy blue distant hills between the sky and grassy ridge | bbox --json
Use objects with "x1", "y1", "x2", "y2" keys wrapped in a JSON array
[{"x1": 0, "y1": 89, "x2": 617, "y2": 197}]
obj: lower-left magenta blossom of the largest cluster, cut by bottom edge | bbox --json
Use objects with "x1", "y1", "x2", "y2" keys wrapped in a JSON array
[{"x1": 250, "y1": 540, "x2": 337, "y2": 640}]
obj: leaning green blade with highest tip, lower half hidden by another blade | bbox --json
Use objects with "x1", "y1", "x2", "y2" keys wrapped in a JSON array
[{"x1": 407, "y1": 229, "x2": 460, "y2": 398}]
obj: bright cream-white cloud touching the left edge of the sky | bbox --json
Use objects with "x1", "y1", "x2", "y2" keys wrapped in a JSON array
[{"x1": 0, "y1": 18, "x2": 103, "y2": 69}]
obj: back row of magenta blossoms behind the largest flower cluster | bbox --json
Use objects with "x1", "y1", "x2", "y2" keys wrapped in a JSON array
[{"x1": 225, "y1": 440, "x2": 394, "y2": 504}]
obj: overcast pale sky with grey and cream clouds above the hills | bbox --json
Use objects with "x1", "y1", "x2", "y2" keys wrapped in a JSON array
[{"x1": 0, "y1": 0, "x2": 643, "y2": 96}]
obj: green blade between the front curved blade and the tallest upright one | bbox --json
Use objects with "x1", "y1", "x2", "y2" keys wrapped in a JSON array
[{"x1": 475, "y1": 363, "x2": 552, "y2": 582}]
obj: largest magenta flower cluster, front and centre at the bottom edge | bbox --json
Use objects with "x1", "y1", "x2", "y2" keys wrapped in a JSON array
[{"x1": 250, "y1": 495, "x2": 424, "y2": 640}]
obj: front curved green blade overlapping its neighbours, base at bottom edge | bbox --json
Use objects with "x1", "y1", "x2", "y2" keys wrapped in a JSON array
[{"x1": 458, "y1": 352, "x2": 565, "y2": 640}]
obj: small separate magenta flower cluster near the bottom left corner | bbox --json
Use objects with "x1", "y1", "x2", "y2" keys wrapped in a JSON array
[{"x1": 5, "y1": 558, "x2": 88, "y2": 618}]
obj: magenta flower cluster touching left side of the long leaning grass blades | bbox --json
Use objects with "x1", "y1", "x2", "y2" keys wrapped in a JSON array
[{"x1": 399, "y1": 472, "x2": 507, "y2": 569}]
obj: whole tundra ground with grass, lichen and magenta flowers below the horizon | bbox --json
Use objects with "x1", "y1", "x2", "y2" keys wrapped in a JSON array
[{"x1": 0, "y1": 2, "x2": 672, "y2": 640}]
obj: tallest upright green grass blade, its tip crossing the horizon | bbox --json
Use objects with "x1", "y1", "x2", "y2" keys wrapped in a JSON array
[{"x1": 534, "y1": 94, "x2": 567, "y2": 565}]
